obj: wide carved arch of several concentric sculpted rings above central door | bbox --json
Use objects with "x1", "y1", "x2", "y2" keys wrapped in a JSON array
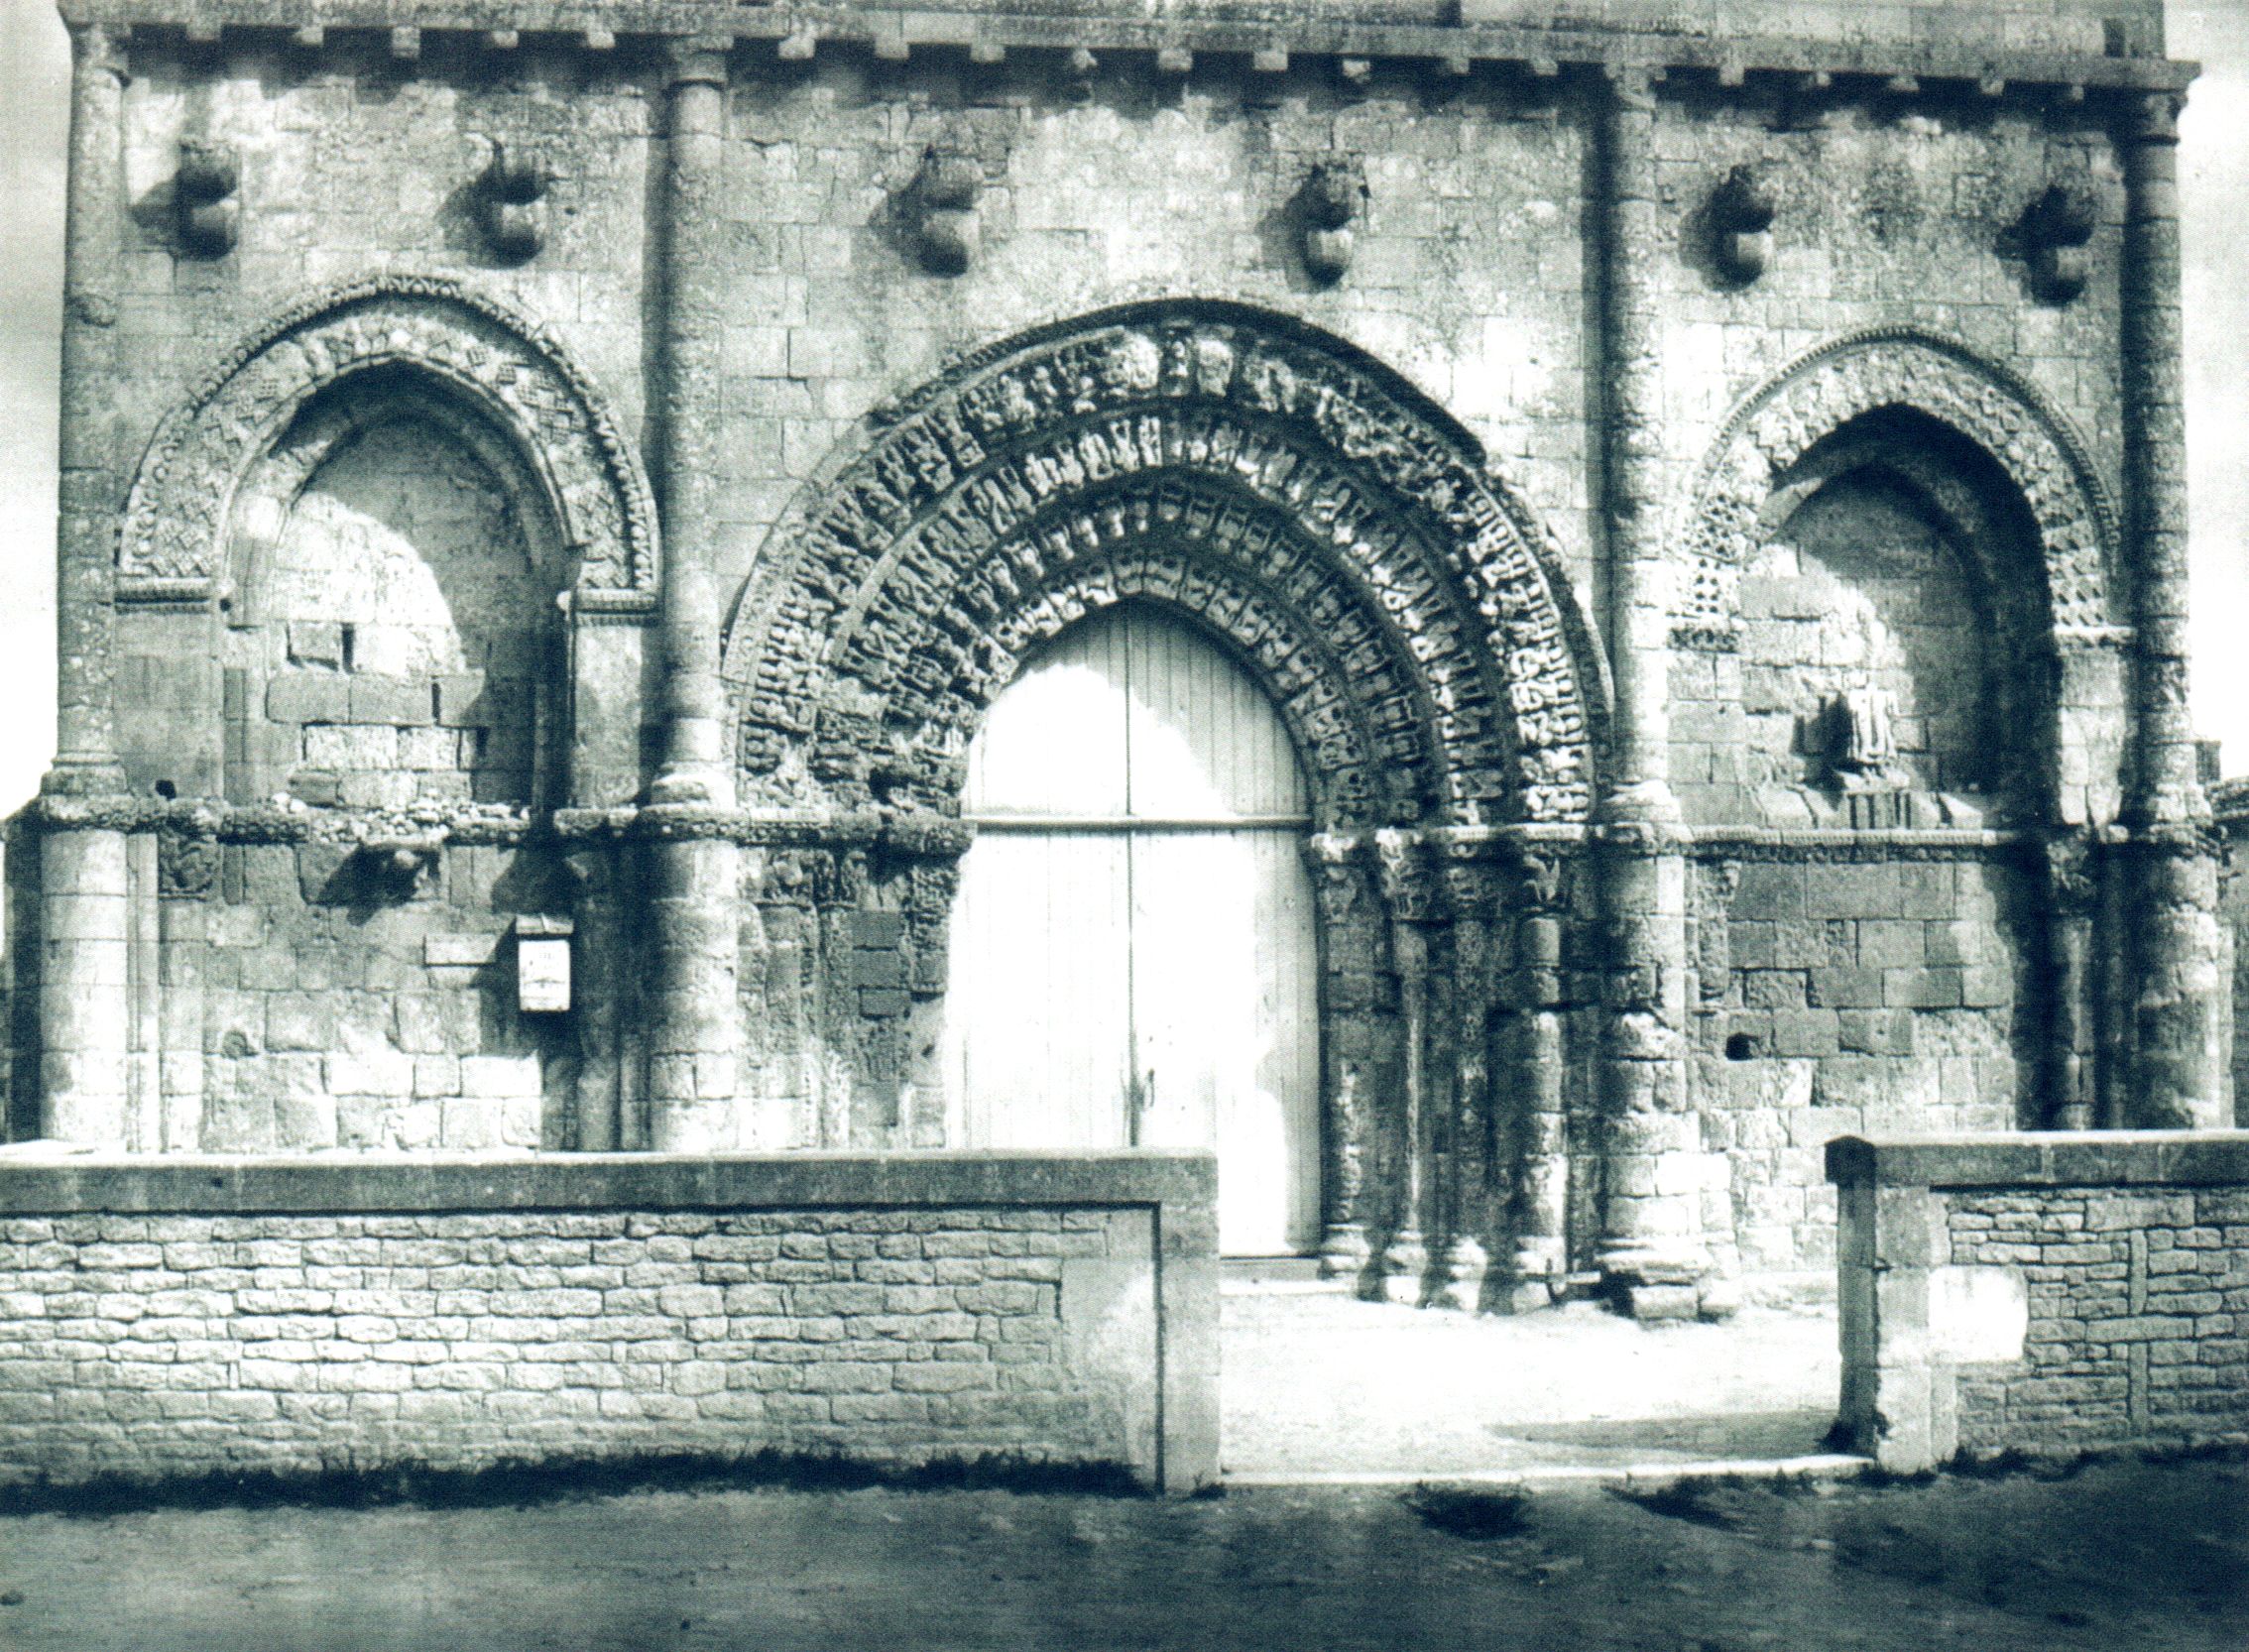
[{"x1": 727, "y1": 301, "x2": 1593, "y2": 823}]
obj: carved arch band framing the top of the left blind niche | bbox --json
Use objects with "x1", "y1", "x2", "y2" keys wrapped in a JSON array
[{"x1": 117, "y1": 275, "x2": 661, "y2": 607}]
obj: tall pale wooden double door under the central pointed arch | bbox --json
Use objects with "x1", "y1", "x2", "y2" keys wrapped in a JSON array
[{"x1": 945, "y1": 602, "x2": 1320, "y2": 1256}]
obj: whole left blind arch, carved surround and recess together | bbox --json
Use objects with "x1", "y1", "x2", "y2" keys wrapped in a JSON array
[{"x1": 117, "y1": 275, "x2": 659, "y2": 809}]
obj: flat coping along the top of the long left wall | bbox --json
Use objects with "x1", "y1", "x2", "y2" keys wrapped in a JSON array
[{"x1": 0, "y1": 1141, "x2": 1219, "y2": 1234}]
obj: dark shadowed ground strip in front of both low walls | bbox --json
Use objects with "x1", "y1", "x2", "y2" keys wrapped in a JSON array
[{"x1": 0, "y1": 1461, "x2": 2249, "y2": 1652}]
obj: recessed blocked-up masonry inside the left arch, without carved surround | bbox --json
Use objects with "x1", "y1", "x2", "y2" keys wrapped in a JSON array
[{"x1": 218, "y1": 369, "x2": 576, "y2": 809}]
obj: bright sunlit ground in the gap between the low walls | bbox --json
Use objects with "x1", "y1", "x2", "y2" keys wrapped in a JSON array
[{"x1": 1222, "y1": 1288, "x2": 1841, "y2": 1478}]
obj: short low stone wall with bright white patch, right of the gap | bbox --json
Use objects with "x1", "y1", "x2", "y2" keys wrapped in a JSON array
[{"x1": 1829, "y1": 1130, "x2": 2249, "y2": 1470}]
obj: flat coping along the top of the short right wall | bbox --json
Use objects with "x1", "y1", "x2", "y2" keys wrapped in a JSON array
[{"x1": 1827, "y1": 1130, "x2": 2249, "y2": 1187}]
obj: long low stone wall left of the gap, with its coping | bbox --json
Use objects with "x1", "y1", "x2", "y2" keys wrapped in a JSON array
[{"x1": 0, "y1": 1153, "x2": 1219, "y2": 1490}]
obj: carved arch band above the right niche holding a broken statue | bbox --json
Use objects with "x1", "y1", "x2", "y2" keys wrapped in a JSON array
[{"x1": 1673, "y1": 328, "x2": 2125, "y2": 648}]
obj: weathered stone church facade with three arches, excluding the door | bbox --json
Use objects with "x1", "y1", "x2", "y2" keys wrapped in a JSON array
[{"x1": 7, "y1": 0, "x2": 2233, "y2": 1315}]
